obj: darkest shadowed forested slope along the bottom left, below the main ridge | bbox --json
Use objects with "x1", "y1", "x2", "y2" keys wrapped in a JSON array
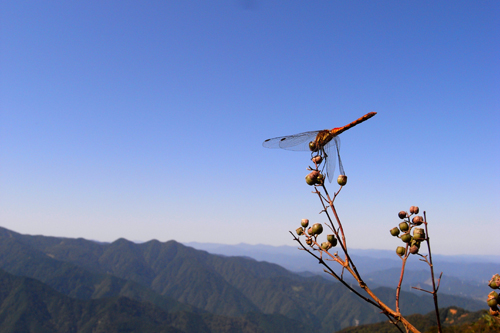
[{"x1": 0, "y1": 270, "x2": 308, "y2": 333}]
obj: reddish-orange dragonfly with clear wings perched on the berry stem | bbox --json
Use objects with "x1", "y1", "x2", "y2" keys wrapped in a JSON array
[{"x1": 262, "y1": 112, "x2": 377, "y2": 183}]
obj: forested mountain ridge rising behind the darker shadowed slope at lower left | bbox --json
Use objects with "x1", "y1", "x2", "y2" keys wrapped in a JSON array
[{"x1": 0, "y1": 229, "x2": 485, "y2": 332}]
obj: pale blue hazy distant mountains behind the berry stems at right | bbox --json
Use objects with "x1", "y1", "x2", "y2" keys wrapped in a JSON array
[{"x1": 184, "y1": 242, "x2": 500, "y2": 301}]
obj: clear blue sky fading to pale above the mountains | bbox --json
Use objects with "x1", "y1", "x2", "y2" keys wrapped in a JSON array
[{"x1": 0, "y1": 0, "x2": 500, "y2": 254}]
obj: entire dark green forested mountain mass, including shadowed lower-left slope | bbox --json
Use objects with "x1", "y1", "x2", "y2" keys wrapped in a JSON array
[{"x1": 0, "y1": 228, "x2": 489, "y2": 332}]
